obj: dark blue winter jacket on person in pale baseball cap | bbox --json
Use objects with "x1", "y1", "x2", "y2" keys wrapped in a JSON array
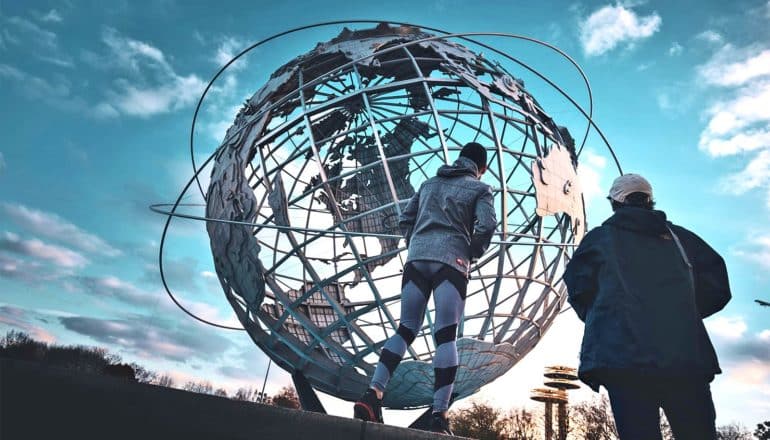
[{"x1": 564, "y1": 207, "x2": 731, "y2": 390}]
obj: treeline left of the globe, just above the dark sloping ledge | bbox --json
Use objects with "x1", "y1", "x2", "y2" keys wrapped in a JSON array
[{"x1": 0, "y1": 330, "x2": 299, "y2": 409}]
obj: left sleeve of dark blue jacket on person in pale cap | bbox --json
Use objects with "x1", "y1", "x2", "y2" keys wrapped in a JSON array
[{"x1": 563, "y1": 231, "x2": 601, "y2": 322}]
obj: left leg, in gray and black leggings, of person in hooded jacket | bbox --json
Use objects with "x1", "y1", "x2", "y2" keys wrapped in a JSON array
[{"x1": 370, "y1": 261, "x2": 431, "y2": 397}]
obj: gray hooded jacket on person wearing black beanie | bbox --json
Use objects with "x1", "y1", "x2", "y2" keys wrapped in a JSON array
[{"x1": 399, "y1": 156, "x2": 497, "y2": 274}]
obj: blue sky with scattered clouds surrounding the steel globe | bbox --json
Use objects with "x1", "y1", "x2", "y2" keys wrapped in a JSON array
[{"x1": 0, "y1": 0, "x2": 770, "y2": 426}]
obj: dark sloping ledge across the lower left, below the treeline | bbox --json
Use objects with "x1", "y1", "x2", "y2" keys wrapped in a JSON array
[{"x1": 0, "y1": 359, "x2": 446, "y2": 440}]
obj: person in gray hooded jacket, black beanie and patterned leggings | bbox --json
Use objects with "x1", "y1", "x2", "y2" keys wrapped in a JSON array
[{"x1": 354, "y1": 142, "x2": 497, "y2": 433}]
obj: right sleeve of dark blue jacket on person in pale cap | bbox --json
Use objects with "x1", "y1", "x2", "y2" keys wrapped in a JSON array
[{"x1": 673, "y1": 226, "x2": 732, "y2": 318}]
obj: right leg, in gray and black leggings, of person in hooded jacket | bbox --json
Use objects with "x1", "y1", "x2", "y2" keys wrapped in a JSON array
[{"x1": 433, "y1": 265, "x2": 468, "y2": 414}]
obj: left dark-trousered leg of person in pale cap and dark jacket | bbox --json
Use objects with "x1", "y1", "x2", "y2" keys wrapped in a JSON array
[{"x1": 605, "y1": 378, "x2": 662, "y2": 440}]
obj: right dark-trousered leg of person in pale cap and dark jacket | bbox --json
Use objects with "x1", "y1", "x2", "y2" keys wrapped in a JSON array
[{"x1": 663, "y1": 380, "x2": 717, "y2": 440}]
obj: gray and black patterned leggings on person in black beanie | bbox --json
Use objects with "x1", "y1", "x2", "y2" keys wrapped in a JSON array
[{"x1": 371, "y1": 261, "x2": 468, "y2": 412}]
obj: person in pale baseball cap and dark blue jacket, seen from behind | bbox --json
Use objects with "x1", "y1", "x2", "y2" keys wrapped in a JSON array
[{"x1": 564, "y1": 174, "x2": 731, "y2": 440}]
